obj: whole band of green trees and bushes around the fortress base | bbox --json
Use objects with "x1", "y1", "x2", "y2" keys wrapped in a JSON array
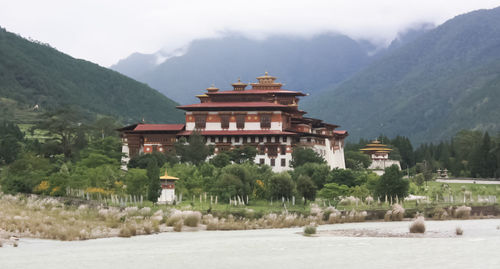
[{"x1": 0, "y1": 108, "x2": 500, "y2": 204}]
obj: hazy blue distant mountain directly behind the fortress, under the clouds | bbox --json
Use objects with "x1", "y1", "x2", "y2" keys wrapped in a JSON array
[{"x1": 111, "y1": 34, "x2": 375, "y2": 104}]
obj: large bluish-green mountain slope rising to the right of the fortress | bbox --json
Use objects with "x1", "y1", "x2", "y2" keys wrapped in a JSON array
[{"x1": 303, "y1": 8, "x2": 500, "y2": 143}]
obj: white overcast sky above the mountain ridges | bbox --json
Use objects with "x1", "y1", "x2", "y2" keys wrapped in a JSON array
[{"x1": 0, "y1": 0, "x2": 500, "y2": 66}]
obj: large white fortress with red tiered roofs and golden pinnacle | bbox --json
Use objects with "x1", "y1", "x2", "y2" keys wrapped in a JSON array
[{"x1": 119, "y1": 72, "x2": 348, "y2": 172}]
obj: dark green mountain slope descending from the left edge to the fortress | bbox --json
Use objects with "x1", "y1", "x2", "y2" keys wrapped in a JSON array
[{"x1": 0, "y1": 28, "x2": 183, "y2": 123}]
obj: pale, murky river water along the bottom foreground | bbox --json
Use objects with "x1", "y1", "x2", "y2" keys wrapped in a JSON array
[{"x1": 0, "y1": 220, "x2": 500, "y2": 269}]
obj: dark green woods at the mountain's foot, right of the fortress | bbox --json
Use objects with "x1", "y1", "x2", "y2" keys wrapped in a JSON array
[{"x1": 346, "y1": 130, "x2": 500, "y2": 178}]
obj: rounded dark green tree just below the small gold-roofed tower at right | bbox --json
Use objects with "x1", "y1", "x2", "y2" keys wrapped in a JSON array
[{"x1": 375, "y1": 165, "x2": 410, "y2": 199}]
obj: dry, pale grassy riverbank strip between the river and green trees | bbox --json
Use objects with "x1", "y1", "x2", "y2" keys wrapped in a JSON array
[{"x1": 0, "y1": 195, "x2": 500, "y2": 244}]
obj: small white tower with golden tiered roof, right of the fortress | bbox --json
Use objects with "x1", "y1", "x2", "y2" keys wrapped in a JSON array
[{"x1": 361, "y1": 140, "x2": 401, "y2": 176}]
